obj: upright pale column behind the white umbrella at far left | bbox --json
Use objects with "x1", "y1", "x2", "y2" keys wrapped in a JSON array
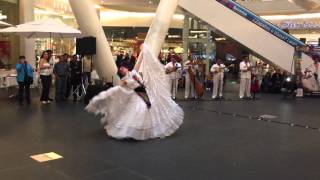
[{"x1": 19, "y1": 0, "x2": 36, "y2": 66}]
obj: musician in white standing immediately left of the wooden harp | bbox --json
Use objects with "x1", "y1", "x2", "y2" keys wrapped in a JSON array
[{"x1": 183, "y1": 58, "x2": 198, "y2": 99}]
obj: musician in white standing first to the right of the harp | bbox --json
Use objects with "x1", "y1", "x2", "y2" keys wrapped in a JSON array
[{"x1": 210, "y1": 59, "x2": 226, "y2": 99}]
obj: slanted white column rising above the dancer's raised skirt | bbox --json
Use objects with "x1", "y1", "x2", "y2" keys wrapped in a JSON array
[{"x1": 145, "y1": 0, "x2": 178, "y2": 57}]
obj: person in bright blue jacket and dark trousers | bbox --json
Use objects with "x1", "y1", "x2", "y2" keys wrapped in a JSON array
[{"x1": 16, "y1": 56, "x2": 33, "y2": 104}]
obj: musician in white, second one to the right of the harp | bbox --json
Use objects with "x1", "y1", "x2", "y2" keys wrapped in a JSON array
[{"x1": 239, "y1": 55, "x2": 252, "y2": 99}]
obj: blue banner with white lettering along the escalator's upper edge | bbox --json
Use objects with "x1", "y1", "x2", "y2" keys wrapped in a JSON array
[{"x1": 216, "y1": 0, "x2": 305, "y2": 47}]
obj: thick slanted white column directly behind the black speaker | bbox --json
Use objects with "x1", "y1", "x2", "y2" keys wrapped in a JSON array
[{"x1": 69, "y1": 0, "x2": 117, "y2": 81}]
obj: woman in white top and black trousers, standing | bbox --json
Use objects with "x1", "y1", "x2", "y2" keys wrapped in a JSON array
[{"x1": 39, "y1": 51, "x2": 52, "y2": 104}]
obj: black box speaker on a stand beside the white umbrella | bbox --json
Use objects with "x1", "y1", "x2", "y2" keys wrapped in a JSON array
[{"x1": 76, "y1": 37, "x2": 97, "y2": 55}]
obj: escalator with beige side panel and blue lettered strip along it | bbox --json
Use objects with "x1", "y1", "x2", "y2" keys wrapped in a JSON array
[{"x1": 179, "y1": 0, "x2": 313, "y2": 72}]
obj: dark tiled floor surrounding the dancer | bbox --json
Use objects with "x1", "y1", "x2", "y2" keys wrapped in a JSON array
[{"x1": 0, "y1": 88, "x2": 320, "y2": 180}]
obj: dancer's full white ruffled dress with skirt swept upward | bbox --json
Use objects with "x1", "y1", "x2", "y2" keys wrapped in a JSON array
[{"x1": 86, "y1": 45, "x2": 184, "y2": 140}]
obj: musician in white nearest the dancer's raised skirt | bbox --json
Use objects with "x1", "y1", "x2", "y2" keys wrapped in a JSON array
[{"x1": 165, "y1": 56, "x2": 181, "y2": 99}]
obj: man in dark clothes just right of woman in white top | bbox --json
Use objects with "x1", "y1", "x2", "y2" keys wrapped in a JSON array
[{"x1": 53, "y1": 54, "x2": 69, "y2": 102}]
